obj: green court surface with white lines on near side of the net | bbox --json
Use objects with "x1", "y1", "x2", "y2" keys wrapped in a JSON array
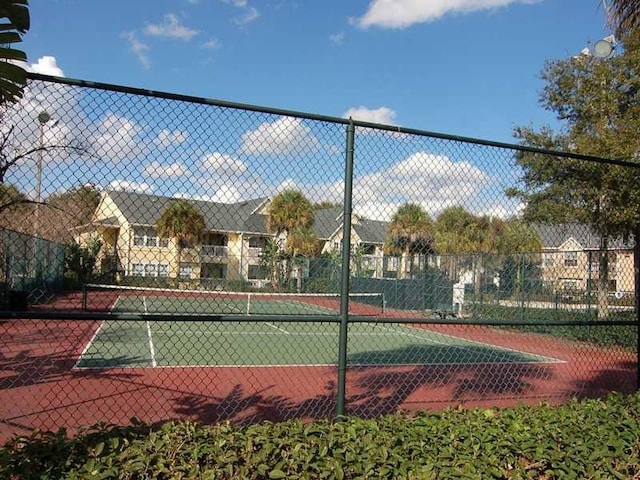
[{"x1": 75, "y1": 320, "x2": 558, "y2": 369}]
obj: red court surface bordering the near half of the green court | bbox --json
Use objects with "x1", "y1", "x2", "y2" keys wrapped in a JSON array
[{"x1": 0, "y1": 320, "x2": 637, "y2": 442}]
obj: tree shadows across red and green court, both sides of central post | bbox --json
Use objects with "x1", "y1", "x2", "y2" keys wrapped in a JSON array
[{"x1": 165, "y1": 345, "x2": 553, "y2": 423}]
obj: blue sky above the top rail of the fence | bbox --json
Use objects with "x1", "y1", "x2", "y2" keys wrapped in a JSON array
[{"x1": 24, "y1": 0, "x2": 608, "y2": 141}]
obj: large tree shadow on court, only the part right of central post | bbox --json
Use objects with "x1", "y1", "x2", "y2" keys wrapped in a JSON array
[{"x1": 340, "y1": 345, "x2": 553, "y2": 417}]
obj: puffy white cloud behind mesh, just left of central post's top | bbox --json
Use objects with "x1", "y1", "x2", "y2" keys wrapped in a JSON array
[{"x1": 241, "y1": 117, "x2": 320, "y2": 155}]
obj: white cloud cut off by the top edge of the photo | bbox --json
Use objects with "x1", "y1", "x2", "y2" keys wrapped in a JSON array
[{"x1": 352, "y1": 0, "x2": 540, "y2": 28}]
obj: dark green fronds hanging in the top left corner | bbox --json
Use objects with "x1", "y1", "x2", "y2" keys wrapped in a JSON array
[{"x1": 0, "y1": 0, "x2": 30, "y2": 104}]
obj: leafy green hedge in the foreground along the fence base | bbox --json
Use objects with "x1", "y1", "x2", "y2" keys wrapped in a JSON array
[{"x1": 0, "y1": 394, "x2": 640, "y2": 480}]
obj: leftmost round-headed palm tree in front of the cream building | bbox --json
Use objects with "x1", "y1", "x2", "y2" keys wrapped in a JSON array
[{"x1": 156, "y1": 200, "x2": 205, "y2": 278}]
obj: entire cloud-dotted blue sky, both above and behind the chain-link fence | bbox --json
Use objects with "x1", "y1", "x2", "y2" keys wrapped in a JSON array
[{"x1": 10, "y1": 0, "x2": 609, "y2": 219}]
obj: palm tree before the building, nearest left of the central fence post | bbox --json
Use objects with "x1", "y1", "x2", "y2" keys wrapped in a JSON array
[{"x1": 267, "y1": 189, "x2": 315, "y2": 289}]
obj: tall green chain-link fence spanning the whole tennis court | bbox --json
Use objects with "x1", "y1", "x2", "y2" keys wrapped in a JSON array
[{"x1": 0, "y1": 74, "x2": 639, "y2": 438}]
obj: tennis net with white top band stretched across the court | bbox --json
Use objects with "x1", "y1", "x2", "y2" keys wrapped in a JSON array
[{"x1": 82, "y1": 284, "x2": 384, "y2": 315}]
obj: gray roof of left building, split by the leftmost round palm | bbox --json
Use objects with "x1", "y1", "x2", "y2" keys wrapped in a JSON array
[{"x1": 108, "y1": 191, "x2": 267, "y2": 234}]
